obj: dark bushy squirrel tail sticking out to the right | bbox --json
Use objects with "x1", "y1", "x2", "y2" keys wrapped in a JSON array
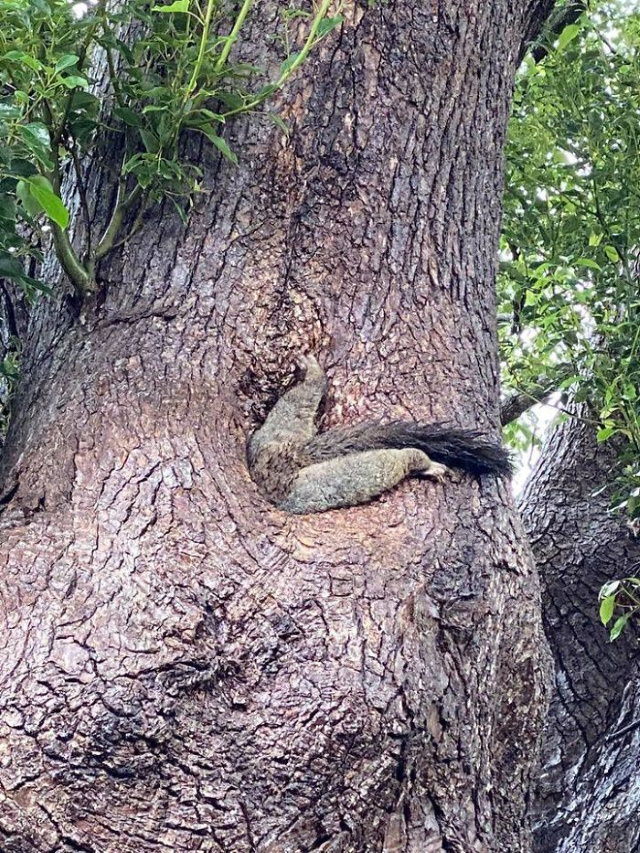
[{"x1": 304, "y1": 421, "x2": 513, "y2": 476}]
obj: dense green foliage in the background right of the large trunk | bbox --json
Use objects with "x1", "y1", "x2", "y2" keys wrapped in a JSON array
[{"x1": 500, "y1": 2, "x2": 640, "y2": 518}]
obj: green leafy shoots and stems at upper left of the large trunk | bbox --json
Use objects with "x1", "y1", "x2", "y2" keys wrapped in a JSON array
[{"x1": 0, "y1": 0, "x2": 342, "y2": 294}]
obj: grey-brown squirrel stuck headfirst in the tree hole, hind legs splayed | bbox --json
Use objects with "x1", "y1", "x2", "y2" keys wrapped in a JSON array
[{"x1": 247, "y1": 356, "x2": 512, "y2": 514}]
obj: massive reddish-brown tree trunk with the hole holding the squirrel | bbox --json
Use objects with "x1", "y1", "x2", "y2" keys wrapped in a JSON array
[{"x1": 0, "y1": 0, "x2": 550, "y2": 853}]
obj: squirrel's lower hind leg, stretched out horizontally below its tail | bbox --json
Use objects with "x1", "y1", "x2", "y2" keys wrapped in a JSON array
[{"x1": 278, "y1": 448, "x2": 447, "y2": 513}]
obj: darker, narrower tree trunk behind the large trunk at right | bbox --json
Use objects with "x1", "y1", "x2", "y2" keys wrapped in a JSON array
[{"x1": 523, "y1": 420, "x2": 640, "y2": 853}]
